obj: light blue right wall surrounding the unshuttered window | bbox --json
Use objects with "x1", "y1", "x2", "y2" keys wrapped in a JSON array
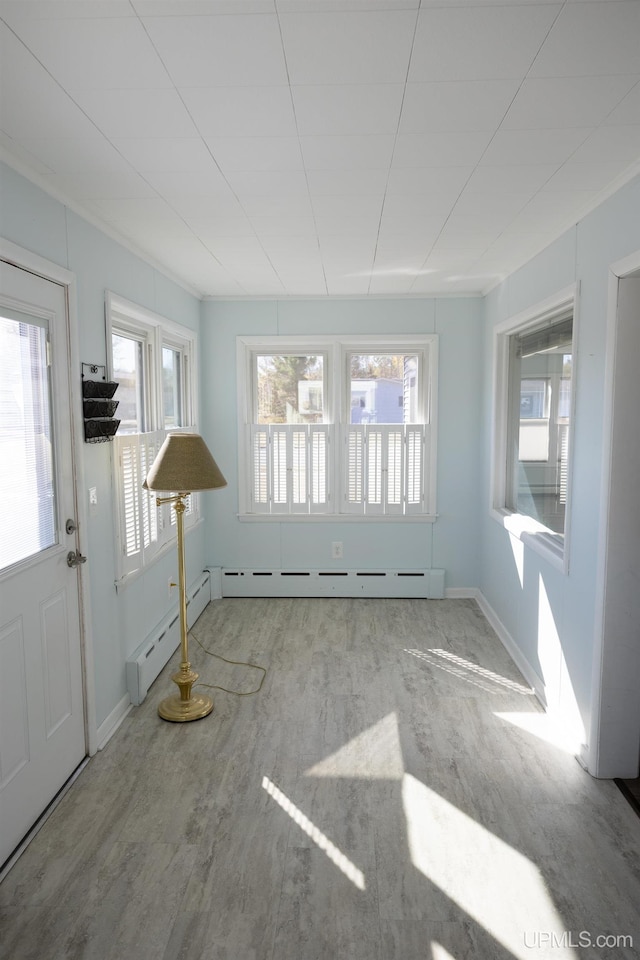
[{"x1": 479, "y1": 179, "x2": 640, "y2": 752}]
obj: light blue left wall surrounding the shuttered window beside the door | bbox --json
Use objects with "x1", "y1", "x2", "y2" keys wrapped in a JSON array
[{"x1": 0, "y1": 165, "x2": 204, "y2": 728}]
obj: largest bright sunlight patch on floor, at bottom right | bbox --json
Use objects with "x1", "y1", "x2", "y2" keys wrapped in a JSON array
[{"x1": 402, "y1": 774, "x2": 576, "y2": 960}]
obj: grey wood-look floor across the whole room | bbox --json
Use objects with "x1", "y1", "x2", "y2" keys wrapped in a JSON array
[{"x1": 0, "y1": 599, "x2": 640, "y2": 960}]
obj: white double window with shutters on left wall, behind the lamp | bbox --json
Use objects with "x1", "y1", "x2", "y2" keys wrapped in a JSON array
[{"x1": 106, "y1": 294, "x2": 197, "y2": 580}]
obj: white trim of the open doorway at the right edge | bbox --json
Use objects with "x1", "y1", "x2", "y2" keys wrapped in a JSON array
[{"x1": 582, "y1": 250, "x2": 640, "y2": 779}]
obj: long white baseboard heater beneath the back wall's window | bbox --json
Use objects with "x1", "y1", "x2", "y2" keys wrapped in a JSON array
[{"x1": 221, "y1": 567, "x2": 444, "y2": 600}]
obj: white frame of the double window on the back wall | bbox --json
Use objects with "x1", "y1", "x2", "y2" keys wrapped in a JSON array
[{"x1": 236, "y1": 334, "x2": 438, "y2": 523}]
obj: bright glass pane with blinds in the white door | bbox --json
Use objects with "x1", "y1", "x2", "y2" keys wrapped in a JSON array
[{"x1": 0, "y1": 317, "x2": 57, "y2": 569}]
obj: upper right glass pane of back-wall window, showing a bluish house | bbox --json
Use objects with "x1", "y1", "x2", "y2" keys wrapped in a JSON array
[{"x1": 349, "y1": 353, "x2": 418, "y2": 423}]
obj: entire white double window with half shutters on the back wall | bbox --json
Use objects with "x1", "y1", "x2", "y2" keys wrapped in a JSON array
[{"x1": 238, "y1": 336, "x2": 437, "y2": 519}]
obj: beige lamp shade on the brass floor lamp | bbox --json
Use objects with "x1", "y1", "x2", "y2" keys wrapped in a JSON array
[{"x1": 142, "y1": 433, "x2": 227, "y2": 493}]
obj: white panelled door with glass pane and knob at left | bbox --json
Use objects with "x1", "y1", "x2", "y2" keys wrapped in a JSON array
[{"x1": 0, "y1": 261, "x2": 86, "y2": 865}]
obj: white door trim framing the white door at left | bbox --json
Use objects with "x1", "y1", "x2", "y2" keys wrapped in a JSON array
[{"x1": 0, "y1": 237, "x2": 98, "y2": 756}]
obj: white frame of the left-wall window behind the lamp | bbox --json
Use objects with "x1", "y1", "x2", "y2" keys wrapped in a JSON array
[{"x1": 105, "y1": 291, "x2": 200, "y2": 588}]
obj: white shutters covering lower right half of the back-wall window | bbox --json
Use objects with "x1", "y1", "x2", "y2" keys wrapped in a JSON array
[{"x1": 344, "y1": 424, "x2": 425, "y2": 516}]
